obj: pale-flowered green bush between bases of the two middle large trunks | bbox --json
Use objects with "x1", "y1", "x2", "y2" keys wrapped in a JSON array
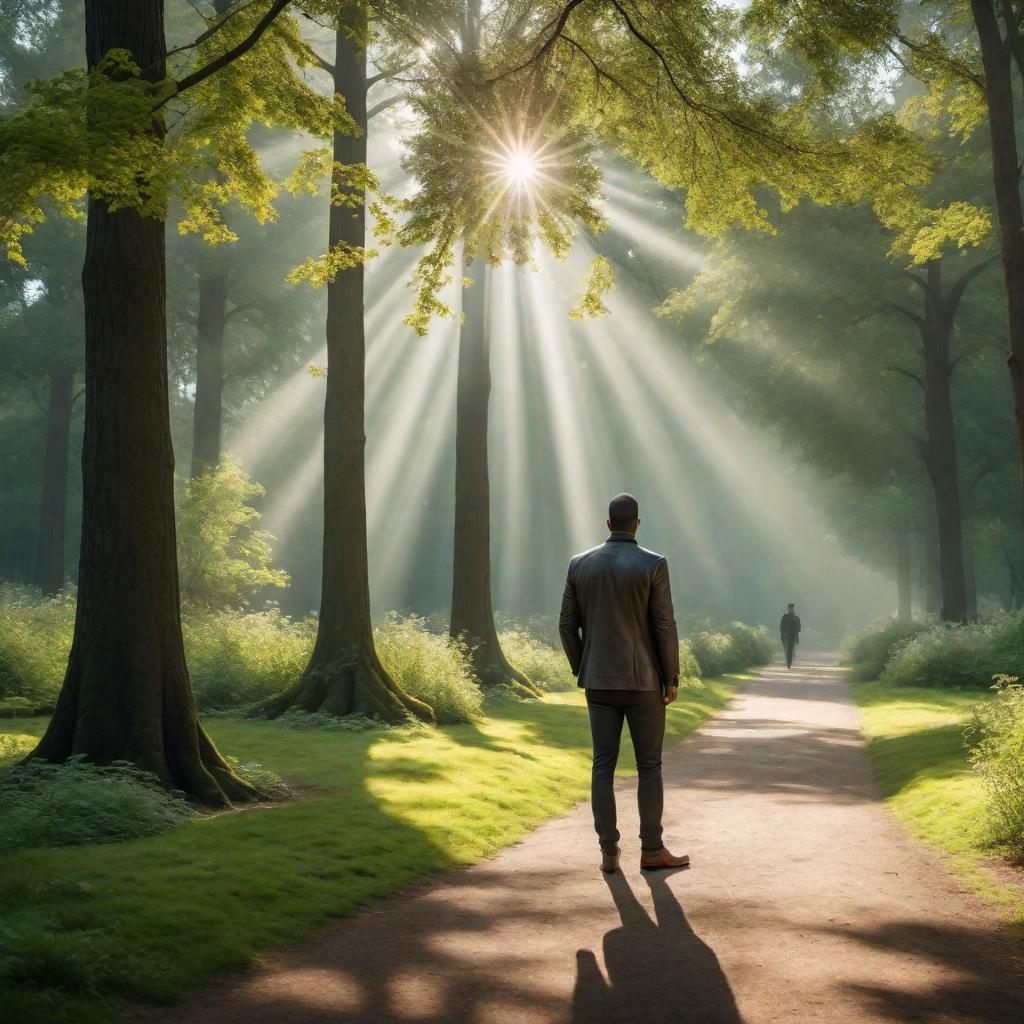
[{"x1": 374, "y1": 612, "x2": 483, "y2": 723}]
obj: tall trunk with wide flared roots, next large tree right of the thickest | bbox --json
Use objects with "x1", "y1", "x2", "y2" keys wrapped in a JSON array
[{"x1": 254, "y1": 14, "x2": 434, "y2": 722}]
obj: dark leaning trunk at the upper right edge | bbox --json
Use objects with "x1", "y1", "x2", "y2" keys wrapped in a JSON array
[{"x1": 971, "y1": 8, "x2": 1024, "y2": 532}]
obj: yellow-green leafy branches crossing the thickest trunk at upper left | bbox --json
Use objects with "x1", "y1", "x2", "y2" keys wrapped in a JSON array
[{"x1": 0, "y1": 3, "x2": 344, "y2": 262}]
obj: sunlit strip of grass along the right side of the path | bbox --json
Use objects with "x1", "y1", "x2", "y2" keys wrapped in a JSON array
[{"x1": 853, "y1": 681, "x2": 1024, "y2": 928}]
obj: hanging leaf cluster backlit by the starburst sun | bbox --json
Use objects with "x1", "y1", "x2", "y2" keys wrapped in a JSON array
[{"x1": 398, "y1": 68, "x2": 609, "y2": 334}]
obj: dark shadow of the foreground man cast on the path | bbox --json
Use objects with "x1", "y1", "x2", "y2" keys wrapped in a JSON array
[{"x1": 572, "y1": 871, "x2": 741, "y2": 1024}]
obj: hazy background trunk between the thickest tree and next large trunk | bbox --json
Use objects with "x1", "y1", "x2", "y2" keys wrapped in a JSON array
[{"x1": 191, "y1": 245, "x2": 227, "y2": 476}]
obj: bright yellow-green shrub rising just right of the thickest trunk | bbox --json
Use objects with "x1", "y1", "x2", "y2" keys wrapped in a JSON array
[{"x1": 177, "y1": 456, "x2": 289, "y2": 608}]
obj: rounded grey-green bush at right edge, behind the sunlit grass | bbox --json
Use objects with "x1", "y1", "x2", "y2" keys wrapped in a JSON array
[{"x1": 882, "y1": 614, "x2": 1024, "y2": 688}]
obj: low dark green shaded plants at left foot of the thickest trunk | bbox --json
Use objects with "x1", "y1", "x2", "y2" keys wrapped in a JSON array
[{"x1": 0, "y1": 756, "x2": 195, "y2": 850}]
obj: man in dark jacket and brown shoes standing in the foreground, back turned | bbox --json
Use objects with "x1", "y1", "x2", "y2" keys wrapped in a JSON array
[{"x1": 558, "y1": 495, "x2": 690, "y2": 872}]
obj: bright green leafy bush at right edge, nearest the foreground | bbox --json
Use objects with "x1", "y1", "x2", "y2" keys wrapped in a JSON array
[{"x1": 967, "y1": 675, "x2": 1024, "y2": 859}]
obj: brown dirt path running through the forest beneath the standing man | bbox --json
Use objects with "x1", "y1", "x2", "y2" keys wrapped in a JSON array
[{"x1": 145, "y1": 655, "x2": 1024, "y2": 1024}]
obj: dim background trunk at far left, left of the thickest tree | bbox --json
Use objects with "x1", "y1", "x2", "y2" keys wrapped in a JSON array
[{"x1": 36, "y1": 368, "x2": 75, "y2": 594}]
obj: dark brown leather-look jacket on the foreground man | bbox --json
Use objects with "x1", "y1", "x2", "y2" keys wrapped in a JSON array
[{"x1": 558, "y1": 531, "x2": 679, "y2": 690}]
